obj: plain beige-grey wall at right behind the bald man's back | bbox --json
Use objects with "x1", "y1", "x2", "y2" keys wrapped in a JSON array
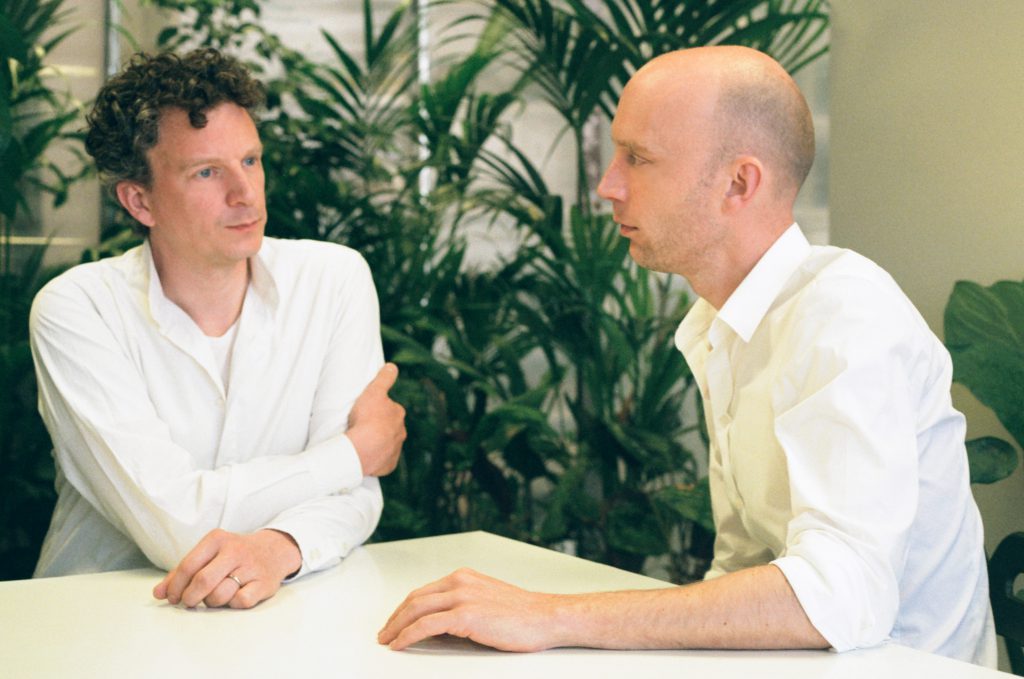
[{"x1": 829, "y1": 0, "x2": 1024, "y2": 561}]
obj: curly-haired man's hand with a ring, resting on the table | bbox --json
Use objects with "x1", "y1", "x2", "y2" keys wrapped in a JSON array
[{"x1": 153, "y1": 528, "x2": 302, "y2": 608}]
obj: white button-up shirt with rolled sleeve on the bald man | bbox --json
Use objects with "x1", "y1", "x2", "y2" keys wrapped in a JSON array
[{"x1": 676, "y1": 224, "x2": 995, "y2": 667}]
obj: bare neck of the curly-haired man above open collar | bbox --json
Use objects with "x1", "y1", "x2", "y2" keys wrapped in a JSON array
[{"x1": 153, "y1": 250, "x2": 249, "y2": 337}]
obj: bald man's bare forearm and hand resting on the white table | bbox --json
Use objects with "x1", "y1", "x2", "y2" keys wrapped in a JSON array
[{"x1": 377, "y1": 564, "x2": 829, "y2": 651}]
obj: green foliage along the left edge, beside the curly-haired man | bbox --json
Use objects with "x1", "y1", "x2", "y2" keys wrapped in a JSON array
[{"x1": 0, "y1": 0, "x2": 87, "y2": 579}]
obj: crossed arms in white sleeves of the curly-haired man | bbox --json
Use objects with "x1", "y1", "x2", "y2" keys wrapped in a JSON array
[{"x1": 32, "y1": 253, "x2": 404, "y2": 606}]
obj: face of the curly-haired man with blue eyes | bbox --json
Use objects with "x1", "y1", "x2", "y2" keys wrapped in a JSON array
[{"x1": 119, "y1": 103, "x2": 266, "y2": 275}]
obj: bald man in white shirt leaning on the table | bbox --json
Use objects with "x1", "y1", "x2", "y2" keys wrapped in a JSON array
[{"x1": 379, "y1": 47, "x2": 995, "y2": 666}]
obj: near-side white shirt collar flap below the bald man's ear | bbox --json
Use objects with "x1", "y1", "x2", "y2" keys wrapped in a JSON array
[{"x1": 718, "y1": 222, "x2": 811, "y2": 342}]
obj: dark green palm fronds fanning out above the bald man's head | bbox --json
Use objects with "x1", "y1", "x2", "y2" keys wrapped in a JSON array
[{"x1": 484, "y1": 0, "x2": 828, "y2": 214}]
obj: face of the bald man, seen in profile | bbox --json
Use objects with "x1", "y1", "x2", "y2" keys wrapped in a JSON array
[{"x1": 597, "y1": 67, "x2": 727, "y2": 277}]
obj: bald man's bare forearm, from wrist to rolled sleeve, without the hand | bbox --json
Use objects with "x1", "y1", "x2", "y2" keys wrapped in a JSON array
[{"x1": 549, "y1": 564, "x2": 828, "y2": 648}]
